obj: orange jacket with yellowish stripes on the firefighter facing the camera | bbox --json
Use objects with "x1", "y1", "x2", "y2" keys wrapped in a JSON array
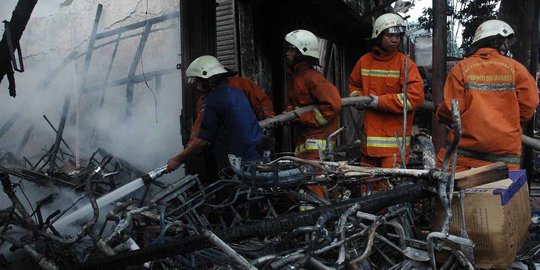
[{"x1": 349, "y1": 47, "x2": 424, "y2": 157}]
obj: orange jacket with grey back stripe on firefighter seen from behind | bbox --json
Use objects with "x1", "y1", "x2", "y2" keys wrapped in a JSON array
[{"x1": 436, "y1": 48, "x2": 538, "y2": 157}]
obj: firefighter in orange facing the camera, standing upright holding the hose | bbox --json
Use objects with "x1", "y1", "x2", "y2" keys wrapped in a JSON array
[{"x1": 349, "y1": 13, "x2": 424, "y2": 168}]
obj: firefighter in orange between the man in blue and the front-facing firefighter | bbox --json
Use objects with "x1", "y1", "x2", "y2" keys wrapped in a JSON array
[{"x1": 285, "y1": 30, "x2": 341, "y2": 197}]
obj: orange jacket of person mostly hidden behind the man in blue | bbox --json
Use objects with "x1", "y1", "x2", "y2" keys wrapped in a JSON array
[{"x1": 188, "y1": 77, "x2": 276, "y2": 144}]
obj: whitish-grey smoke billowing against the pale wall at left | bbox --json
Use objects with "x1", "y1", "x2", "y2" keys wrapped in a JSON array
[{"x1": 0, "y1": 0, "x2": 183, "y2": 262}]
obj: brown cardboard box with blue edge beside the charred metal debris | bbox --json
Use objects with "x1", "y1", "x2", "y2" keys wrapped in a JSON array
[{"x1": 432, "y1": 171, "x2": 531, "y2": 269}]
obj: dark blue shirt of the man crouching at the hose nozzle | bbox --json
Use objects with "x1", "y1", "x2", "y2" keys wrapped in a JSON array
[{"x1": 197, "y1": 84, "x2": 262, "y2": 169}]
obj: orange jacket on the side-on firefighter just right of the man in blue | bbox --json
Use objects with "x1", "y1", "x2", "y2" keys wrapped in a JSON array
[{"x1": 287, "y1": 61, "x2": 341, "y2": 159}]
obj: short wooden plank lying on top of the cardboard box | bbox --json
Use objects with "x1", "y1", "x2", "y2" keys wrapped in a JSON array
[{"x1": 454, "y1": 162, "x2": 508, "y2": 190}]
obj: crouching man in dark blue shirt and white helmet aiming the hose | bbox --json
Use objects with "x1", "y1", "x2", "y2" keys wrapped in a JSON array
[{"x1": 167, "y1": 55, "x2": 262, "y2": 172}]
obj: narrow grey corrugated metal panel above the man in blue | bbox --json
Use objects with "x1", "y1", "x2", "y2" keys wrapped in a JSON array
[{"x1": 216, "y1": 0, "x2": 238, "y2": 70}]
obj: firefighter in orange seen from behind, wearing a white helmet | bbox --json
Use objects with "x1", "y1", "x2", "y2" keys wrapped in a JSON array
[{"x1": 436, "y1": 20, "x2": 538, "y2": 171}]
